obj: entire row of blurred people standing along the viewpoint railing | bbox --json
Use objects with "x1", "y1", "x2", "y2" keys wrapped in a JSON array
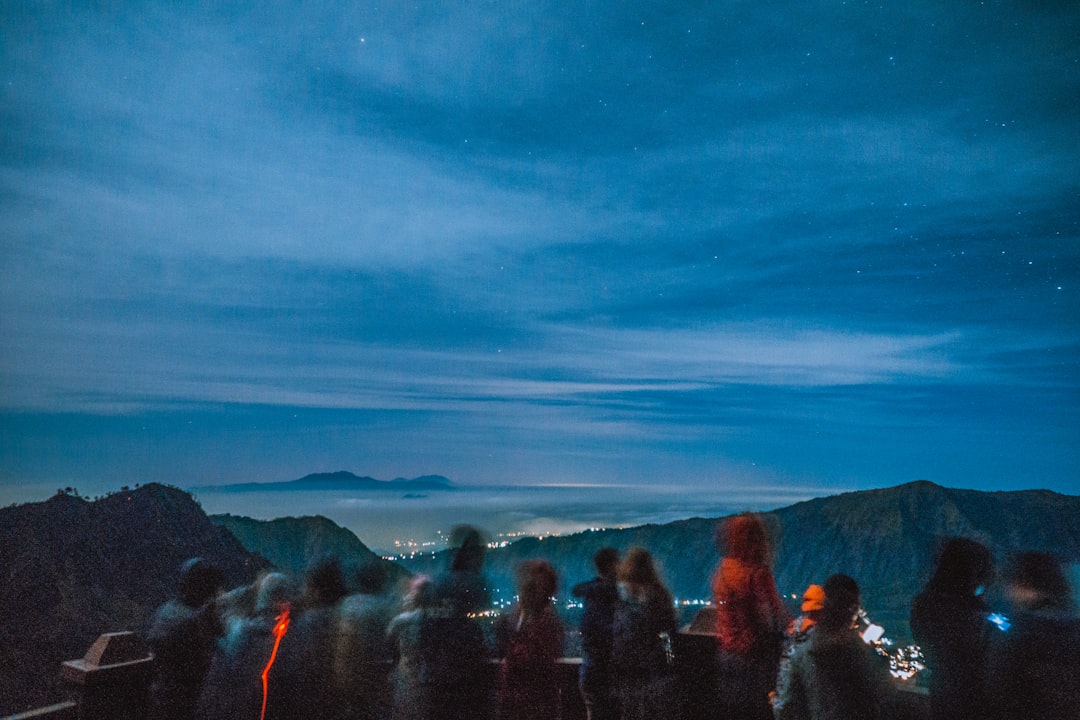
[{"x1": 147, "y1": 514, "x2": 1080, "y2": 720}]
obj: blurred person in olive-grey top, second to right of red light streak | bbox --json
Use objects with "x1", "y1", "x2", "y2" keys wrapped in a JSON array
[{"x1": 334, "y1": 559, "x2": 393, "y2": 720}]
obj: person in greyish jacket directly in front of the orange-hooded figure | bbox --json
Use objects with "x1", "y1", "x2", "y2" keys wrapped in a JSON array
[{"x1": 773, "y1": 574, "x2": 891, "y2": 720}]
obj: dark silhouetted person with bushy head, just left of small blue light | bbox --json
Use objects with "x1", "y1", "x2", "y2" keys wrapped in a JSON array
[{"x1": 910, "y1": 538, "x2": 994, "y2": 720}]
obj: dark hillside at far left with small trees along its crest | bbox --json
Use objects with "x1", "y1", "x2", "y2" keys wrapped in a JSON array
[{"x1": 0, "y1": 484, "x2": 269, "y2": 715}]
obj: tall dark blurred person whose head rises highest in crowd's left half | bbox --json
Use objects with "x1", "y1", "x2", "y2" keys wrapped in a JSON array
[{"x1": 423, "y1": 526, "x2": 490, "y2": 720}]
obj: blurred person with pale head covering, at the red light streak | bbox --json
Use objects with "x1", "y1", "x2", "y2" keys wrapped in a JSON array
[{"x1": 200, "y1": 572, "x2": 293, "y2": 720}]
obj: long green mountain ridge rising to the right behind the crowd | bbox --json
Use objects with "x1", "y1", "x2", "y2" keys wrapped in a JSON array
[{"x1": 402, "y1": 480, "x2": 1080, "y2": 638}]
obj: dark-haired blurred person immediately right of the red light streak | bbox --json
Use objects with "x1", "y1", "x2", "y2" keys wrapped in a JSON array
[{"x1": 278, "y1": 556, "x2": 346, "y2": 720}]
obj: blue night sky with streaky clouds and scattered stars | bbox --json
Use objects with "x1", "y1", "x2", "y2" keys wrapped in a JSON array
[{"x1": 0, "y1": 0, "x2": 1080, "y2": 507}]
